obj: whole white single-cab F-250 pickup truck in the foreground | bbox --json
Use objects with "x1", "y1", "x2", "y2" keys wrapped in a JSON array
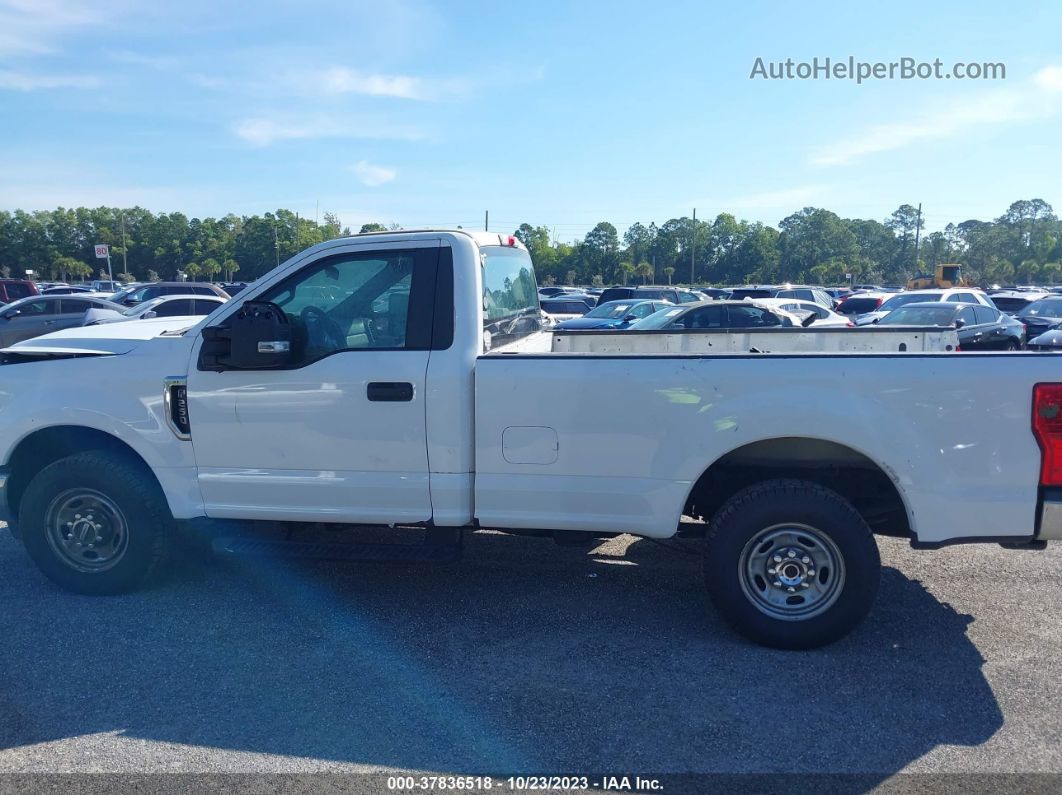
[{"x1": 0, "y1": 230, "x2": 1062, "y2": 649}]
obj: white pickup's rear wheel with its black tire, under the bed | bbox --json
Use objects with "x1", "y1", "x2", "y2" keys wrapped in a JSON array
[{"x1": 704, "y1": 480, "x2": 881, "y2": 649}]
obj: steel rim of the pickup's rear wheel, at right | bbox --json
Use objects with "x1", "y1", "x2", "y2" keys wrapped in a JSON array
[{"x1": 738, "y1": 522, "x2": 845, "y2": 621}]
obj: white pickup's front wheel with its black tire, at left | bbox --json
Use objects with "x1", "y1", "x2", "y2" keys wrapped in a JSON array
[{"x1": 18, "y1": 450, "x2": 174, "y2": 595}]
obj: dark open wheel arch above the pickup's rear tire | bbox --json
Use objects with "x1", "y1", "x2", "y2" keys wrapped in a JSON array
[{"x1": 684, "y1": 436, "x2": 914, "y2": 537}]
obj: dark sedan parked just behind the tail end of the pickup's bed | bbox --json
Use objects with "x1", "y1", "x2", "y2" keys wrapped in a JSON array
[{"x1": 877, "y1": 301, "x2": 1026, "y2": 350}]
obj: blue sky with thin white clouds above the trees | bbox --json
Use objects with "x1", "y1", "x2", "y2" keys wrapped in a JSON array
[{"x1": 0, "y1": 0, "x2": 1062, "y2": 240}]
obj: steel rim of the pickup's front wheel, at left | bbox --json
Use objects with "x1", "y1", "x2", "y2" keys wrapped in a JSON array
[{"x1": 45, "y1": 488, "x2": 129, "y2": 573}]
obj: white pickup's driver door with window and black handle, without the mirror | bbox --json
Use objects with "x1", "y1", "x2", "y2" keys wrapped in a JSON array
[{"x1": 188, "y1": 241, "x2": 439, "y2": 523}]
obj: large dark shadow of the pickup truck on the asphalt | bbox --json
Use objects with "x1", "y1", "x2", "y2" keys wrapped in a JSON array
[{"x1": 0, "y1": 533, "x2": 1003, "y2": 777}]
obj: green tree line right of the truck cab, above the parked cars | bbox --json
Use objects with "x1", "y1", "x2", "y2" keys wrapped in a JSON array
[{"x1": 516, "y1": 198, "x2": 1062, "y2": 286}]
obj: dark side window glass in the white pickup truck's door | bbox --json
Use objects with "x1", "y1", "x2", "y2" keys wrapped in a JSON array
[{"x1": 257, "y1": 248, "x2": 438, "y2": 367}]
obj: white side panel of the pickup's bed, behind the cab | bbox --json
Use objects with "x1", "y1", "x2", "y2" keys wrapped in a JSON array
[{"x1": 475, "y1": 348, "x2": 1049, "y2": 543}]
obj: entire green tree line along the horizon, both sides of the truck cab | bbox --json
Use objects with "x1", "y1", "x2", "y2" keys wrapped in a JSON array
[{"x1": 0, "y1": 198, "x2": 1062, "y2": 284}]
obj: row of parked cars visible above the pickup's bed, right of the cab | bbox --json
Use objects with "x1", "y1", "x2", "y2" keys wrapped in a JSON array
[{"x1": 539, "y1": 284, "x2": 1062, "y2": 350}]
